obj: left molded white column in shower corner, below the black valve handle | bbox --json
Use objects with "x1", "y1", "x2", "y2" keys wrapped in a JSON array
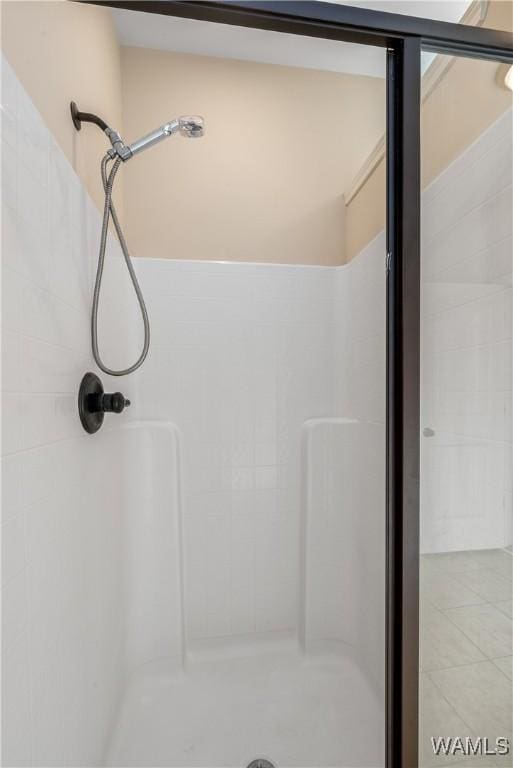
[{"x1": 119, "y1": 421, "x2": 185, "y2": 673}]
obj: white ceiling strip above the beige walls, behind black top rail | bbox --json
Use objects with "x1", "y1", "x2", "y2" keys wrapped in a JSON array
[{"x1": 112, "y1": 0, "x2": 469, "y2": 77}]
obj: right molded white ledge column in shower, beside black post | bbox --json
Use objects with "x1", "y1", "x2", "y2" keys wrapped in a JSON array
[{"x1": 300, "y1": 417, "x2": 385, "y2": 701}]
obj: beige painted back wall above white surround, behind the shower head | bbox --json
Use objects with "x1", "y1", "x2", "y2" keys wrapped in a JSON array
[{"x1": 121, "y1": 48, "x2": 385, "y2": 264}]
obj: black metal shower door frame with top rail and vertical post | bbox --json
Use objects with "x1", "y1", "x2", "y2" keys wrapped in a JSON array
[{"x1": 79, "y1": 0, "x2": 513, "y2": 768}]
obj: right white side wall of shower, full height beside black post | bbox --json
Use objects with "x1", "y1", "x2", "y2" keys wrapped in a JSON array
[{"x1": 326, "y1": 232, "x2": 386, "y2": 692}]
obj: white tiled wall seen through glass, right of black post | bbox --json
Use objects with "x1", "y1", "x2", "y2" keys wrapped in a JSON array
[{"x1": 421, "y1": 110, "x2": 513, "y2": 552}]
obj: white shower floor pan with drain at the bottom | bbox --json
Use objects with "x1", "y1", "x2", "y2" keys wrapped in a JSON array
[{"x1": 107, "y1": 648, "x2": 383, "y2": 768}]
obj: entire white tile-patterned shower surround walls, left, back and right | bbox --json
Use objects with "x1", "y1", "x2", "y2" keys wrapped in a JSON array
[{"x1": 2, "y1": 54, "x2": 511, "y2": 766}]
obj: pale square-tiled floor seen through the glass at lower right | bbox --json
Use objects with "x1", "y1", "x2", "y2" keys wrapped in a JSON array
[{"x1": 420, "y1": 548, "x2": 513, "y2": 768}]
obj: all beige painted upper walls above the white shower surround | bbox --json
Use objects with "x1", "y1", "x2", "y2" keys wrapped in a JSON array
[{"x1": 1, "y1": 0, "x2": 513, "y2": 264}]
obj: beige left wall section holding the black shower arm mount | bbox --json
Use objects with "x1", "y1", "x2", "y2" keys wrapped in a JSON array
[{"x1": 1, "y1": 0, "x2": 122, "y2": 213}]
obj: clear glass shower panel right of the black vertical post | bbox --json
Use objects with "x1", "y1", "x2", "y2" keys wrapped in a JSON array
[{"x1": 420, "y1": 45, "x2": 513, "y2": 766}]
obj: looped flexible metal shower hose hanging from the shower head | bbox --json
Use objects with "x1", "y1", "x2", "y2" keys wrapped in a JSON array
[{"x1": 91, "y1": 154, "x2": 150, "y2": 376}]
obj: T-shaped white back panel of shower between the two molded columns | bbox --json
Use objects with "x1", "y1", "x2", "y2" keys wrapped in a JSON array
[{"x1": 130, "y1": 259, "x2": 333, "y2": 640}]
